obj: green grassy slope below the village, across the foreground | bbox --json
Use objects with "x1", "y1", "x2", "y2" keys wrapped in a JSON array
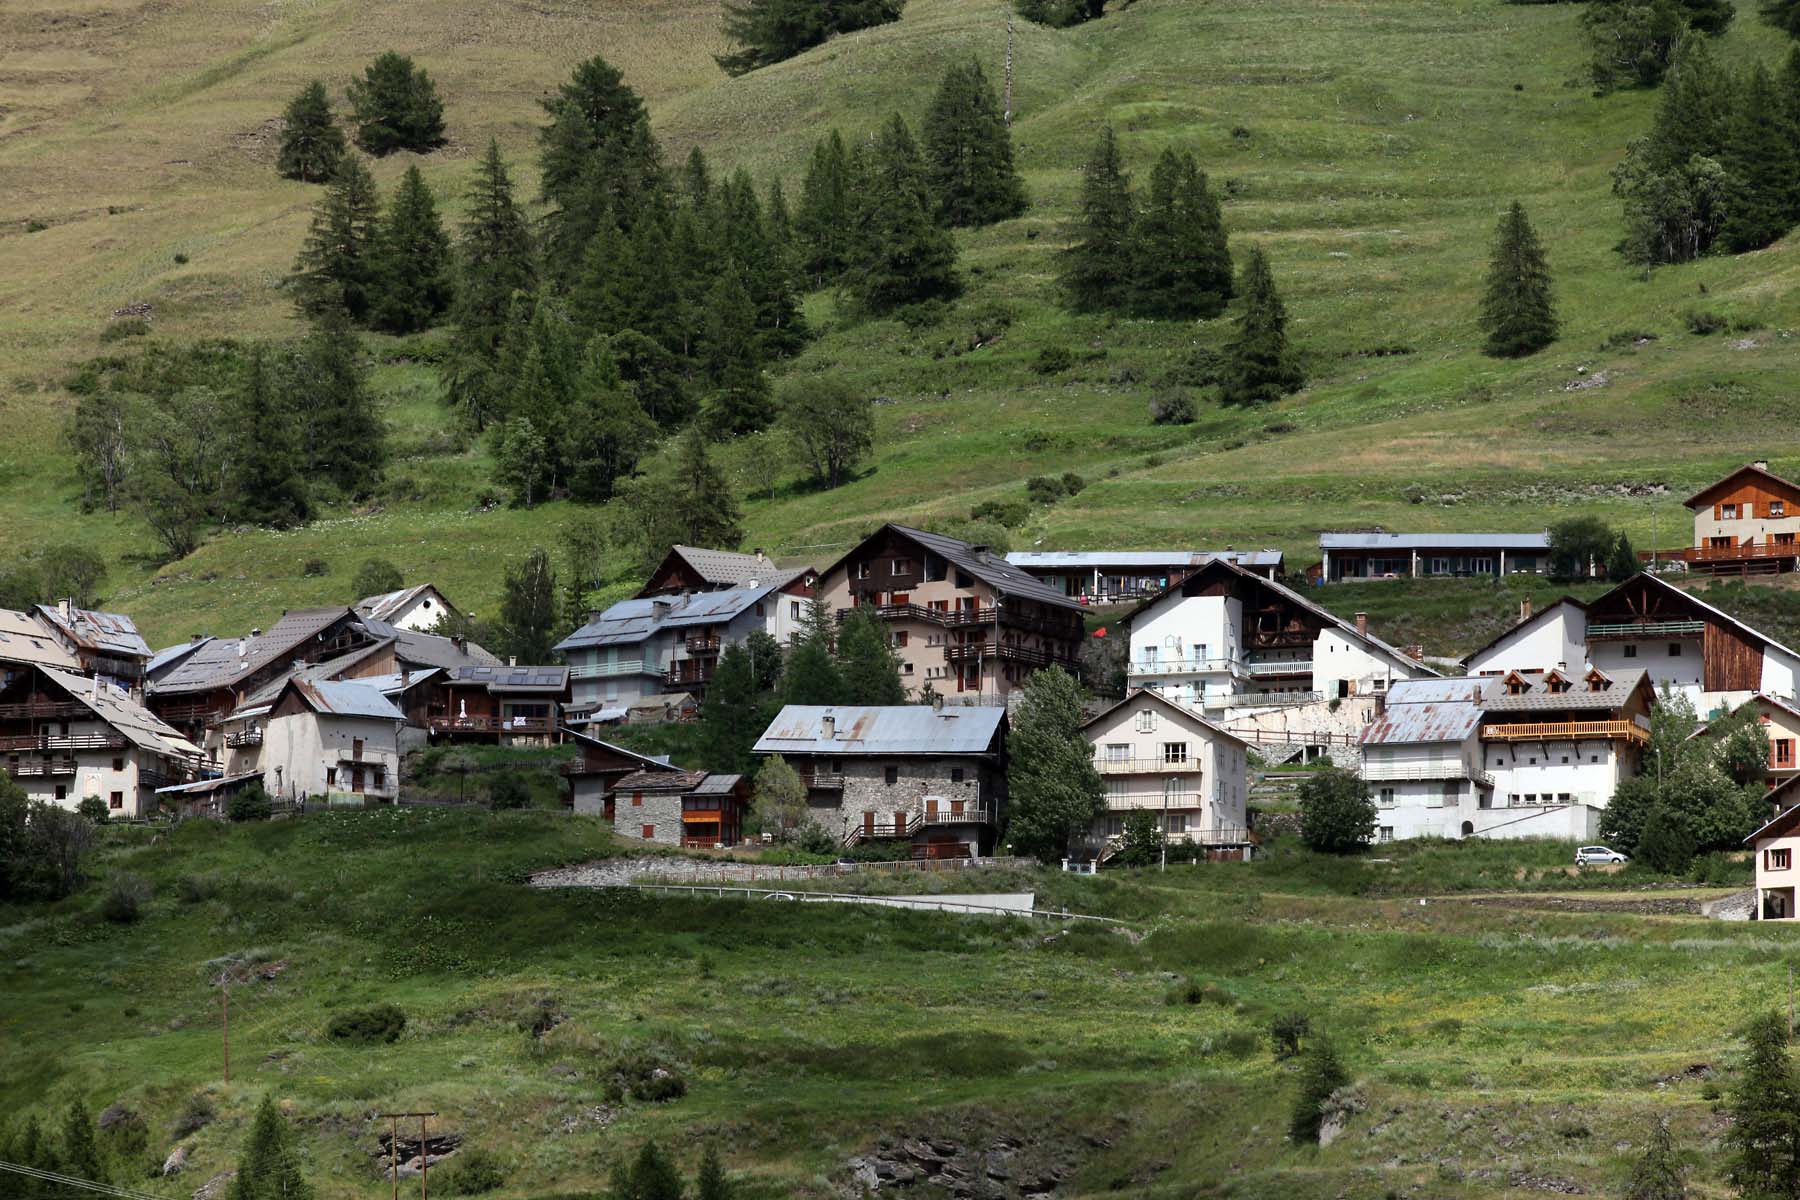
[{"x1": 0, "y1": 810, "x2": 1791, "y2": 1200}]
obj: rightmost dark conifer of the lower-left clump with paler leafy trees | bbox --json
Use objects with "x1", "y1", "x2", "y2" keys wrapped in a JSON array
[{"x1": 281, "y1": 318, "x2": 387, "y2": 497}]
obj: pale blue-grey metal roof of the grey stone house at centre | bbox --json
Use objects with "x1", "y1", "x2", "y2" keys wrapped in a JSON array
[{"x1": 754, "y1": 703, "x2": 1006, "y2": 756}]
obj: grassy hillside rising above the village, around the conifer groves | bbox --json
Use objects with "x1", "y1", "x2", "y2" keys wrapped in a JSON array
[{"x1": 0, "y1": 0, "x2": 1800, "y2": 640}]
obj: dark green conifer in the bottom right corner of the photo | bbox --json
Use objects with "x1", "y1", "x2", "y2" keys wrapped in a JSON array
[{"x1": 1724, "y1": 1013, "x2": 1800, "y2": 1200}]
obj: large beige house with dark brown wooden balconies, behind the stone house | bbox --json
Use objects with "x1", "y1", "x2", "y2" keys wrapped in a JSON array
[{"x1": 819, "y1": 524, "x2": 1082, "y2": 703}]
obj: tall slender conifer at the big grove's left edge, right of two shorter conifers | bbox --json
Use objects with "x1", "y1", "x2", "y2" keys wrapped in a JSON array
[{"x1": 450, "y1": 140, "x2": 536, "y2": 430}]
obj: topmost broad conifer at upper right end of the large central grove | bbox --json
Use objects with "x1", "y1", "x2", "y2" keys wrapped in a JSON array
[{"x1": 925, "y1": 59, "x2": 1026, "y2": 225}]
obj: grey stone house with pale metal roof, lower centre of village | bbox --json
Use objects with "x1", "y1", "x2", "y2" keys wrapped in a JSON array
[{"x1": 756, "y1": 703, "x2": 1006, "y2": 858}]
